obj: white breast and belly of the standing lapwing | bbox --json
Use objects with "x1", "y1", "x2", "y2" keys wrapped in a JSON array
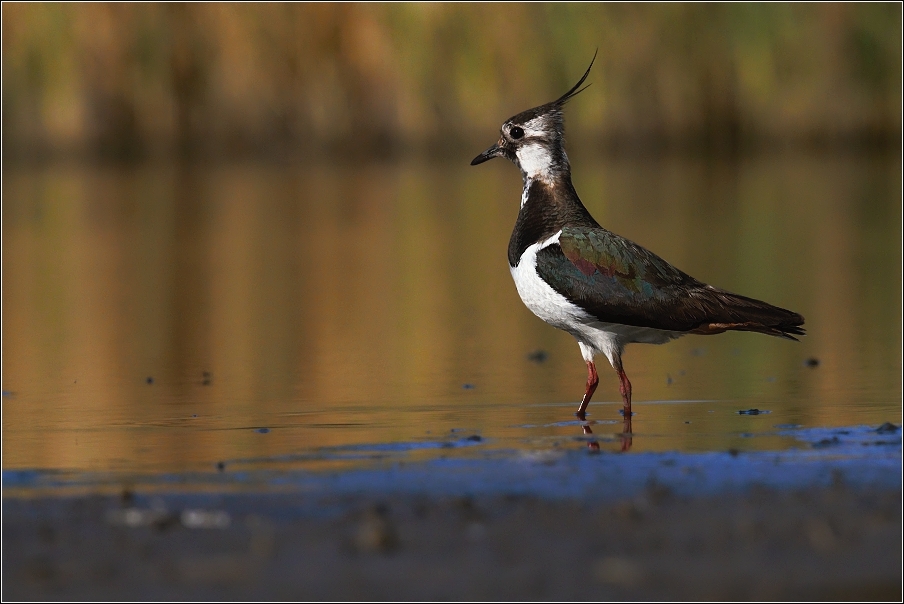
[{"x1": 511, "y1": 231, "x2": 684, "y2": 366}]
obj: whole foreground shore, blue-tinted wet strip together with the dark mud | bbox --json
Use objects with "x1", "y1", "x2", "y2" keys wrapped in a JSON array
[{"x1": 2, "y1": 427, "x2": 902, "y2": 601}]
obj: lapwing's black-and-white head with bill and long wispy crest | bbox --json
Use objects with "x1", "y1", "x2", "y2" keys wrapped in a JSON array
[{"x1": 471, "y1": 53, "x2": 596, "y2": 180}]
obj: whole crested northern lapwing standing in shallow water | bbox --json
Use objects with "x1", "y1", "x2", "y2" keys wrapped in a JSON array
[{"x1": 471, "y1": 54, "x2": 804, "y2": 426}]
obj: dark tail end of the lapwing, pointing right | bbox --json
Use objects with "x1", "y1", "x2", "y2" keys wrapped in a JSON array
[{"x1": 691, "y1": 287, "x2": 806, "y2": 341}]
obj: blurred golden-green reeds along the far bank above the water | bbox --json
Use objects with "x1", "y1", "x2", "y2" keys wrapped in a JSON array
[{"x1": 2, "y1": 3, "x2": 901, "y2": 162}]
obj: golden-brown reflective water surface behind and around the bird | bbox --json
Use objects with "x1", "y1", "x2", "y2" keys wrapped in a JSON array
[{"x1": 2, "y1": 154, "x2": 901, "y2": 471}]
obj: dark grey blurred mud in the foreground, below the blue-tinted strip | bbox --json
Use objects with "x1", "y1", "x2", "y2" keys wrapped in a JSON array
[{"x1": 3, "y1": 484, "x2": 902, "y2": 600}]
